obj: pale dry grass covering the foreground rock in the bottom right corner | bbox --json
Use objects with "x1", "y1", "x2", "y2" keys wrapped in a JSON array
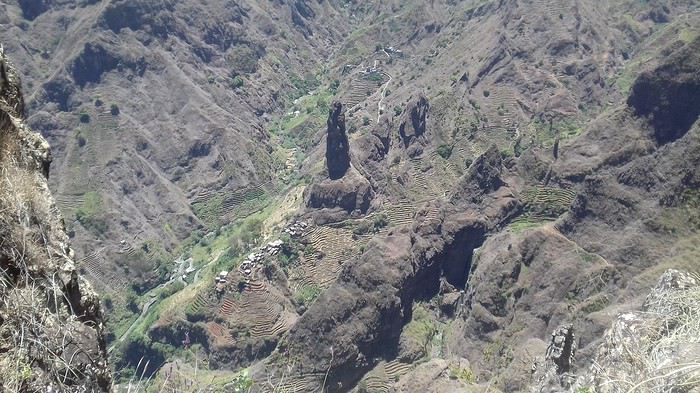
[{"x1": 594, "y1": 274, "x2": 700, "y2": 393}]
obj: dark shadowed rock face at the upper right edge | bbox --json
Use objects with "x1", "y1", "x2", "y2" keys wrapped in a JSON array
[{"x1": 627, "y1": 38, "x2": 700, "y2": 144}]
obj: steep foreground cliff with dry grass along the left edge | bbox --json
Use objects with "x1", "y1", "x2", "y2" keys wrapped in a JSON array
[{"x1": 0, "y1": 48, "x2": 111, "y2": 392}]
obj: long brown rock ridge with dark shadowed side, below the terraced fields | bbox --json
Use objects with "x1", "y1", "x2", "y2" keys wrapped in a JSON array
[{"x1": 274, "y1": 146, "x2": 515, "y2": 392}]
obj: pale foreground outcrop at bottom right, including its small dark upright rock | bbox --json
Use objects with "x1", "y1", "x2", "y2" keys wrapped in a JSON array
[{"x1": 530, "y1": 269, "x2": 700, "y2": 393}]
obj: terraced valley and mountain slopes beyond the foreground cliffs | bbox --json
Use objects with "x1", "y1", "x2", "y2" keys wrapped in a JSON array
[{"x1": 1, "y1": 0, "x2": 700, "y2": 392}]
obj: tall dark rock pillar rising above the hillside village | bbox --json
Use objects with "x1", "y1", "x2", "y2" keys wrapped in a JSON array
[{"x1": 326, "y1": 101, "x2": 350, "y2": 180}]
